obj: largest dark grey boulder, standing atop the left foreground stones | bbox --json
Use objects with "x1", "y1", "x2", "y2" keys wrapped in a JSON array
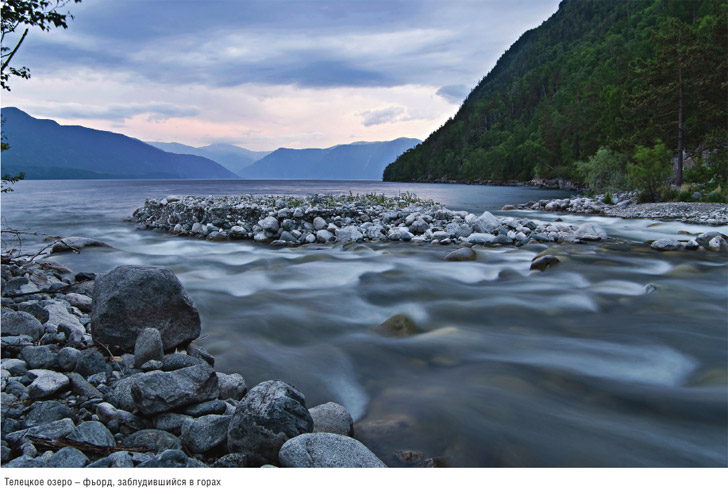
[{"x1": 91, "y1": 266, "x2": 205, "y2": 353}]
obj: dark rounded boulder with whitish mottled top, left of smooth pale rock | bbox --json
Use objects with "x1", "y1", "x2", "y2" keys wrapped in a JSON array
[{"x1": 227, "y1": 381, "x2": 313, "y2": 466}]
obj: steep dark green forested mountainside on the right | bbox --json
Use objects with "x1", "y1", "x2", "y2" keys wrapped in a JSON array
[{"x1": 383, "y1": 0, "x2": 728, "y2": 181}]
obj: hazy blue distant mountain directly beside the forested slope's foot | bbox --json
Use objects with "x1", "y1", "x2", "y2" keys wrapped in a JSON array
[{"x1": 240, "y1": 137, "x2": 421, "y2": 180}]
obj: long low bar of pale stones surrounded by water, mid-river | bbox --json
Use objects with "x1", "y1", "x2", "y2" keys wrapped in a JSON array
[{"x1": 131, "y1": 195, "x2": 607, "y2": 247}]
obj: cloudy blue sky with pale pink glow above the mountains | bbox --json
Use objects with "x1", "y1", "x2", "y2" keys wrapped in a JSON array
[{"x1": 1, "y1": 0, "x2": 559, "y2": 151}]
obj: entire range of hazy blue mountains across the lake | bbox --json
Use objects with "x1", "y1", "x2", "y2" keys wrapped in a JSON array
[{"x1": 2, "y1": 107, "x2": 421, "y2": 180}]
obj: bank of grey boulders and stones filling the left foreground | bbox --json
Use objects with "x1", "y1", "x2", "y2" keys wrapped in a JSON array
[{"x1": 2, "y1": 256, "x2": 385, "y2": 468}]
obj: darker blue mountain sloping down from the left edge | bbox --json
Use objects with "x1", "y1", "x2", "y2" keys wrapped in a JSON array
[{"x1": 2, "y1": 107, "x2": 237, "y2": 179}]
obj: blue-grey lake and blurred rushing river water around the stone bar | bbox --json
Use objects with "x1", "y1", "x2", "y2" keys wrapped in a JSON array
[{"x1": 2, "y1": 181, "x2": 728, "y2": 467}]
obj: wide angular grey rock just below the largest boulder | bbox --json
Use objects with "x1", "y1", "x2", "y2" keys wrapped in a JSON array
[{"x1": 131, "y1": 364, "x2": 219, "y2": 415}]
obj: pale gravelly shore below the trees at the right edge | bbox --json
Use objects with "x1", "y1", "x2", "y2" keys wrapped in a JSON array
[{"x1": 503, "y1": 192, "x2": 728, "y2": 226}]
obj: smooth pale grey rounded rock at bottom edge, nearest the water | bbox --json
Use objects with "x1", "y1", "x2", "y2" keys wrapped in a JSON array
[{"x1": 278, "y1": 432, "x2": 386, "y2": 468}]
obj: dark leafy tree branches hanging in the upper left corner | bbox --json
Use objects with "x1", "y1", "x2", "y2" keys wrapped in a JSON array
[{"x1": 0, "y1": 0, "x2": 81, "y2": 91}]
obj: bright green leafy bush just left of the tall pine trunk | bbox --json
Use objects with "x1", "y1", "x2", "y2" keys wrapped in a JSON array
[{"x1": 627, "y1": 140, "x2": 672, "y2": 202}]
